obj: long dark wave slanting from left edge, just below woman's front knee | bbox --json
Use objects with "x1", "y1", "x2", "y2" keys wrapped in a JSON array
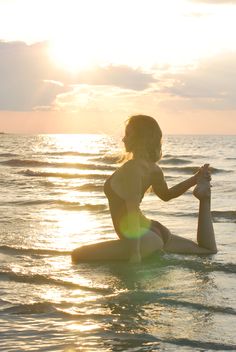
[{"x1": 0, "y1": 271, "x2": 111, "y2": 293}]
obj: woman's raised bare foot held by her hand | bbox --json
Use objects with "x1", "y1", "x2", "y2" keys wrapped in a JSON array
[{"x1": 193, "y1": 164, "x2": 211, "y2": 200}]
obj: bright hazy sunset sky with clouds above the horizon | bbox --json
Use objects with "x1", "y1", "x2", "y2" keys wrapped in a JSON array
[{"x1": 0, "y1": 0, "x2": 236, "y2": 135}]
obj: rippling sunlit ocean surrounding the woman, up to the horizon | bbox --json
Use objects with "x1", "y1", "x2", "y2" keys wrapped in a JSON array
[{"x1": 0, "y1": 134, "x2": 236, "y2": 352}]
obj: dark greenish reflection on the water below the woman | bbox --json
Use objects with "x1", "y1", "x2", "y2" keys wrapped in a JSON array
[{"x1": 69, "y1": 258, "x2": 220, "y2": 351}]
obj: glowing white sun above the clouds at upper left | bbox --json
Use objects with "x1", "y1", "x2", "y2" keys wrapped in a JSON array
[{"x1": 49, "y1": 37, "x2": 98, "y2": 73}]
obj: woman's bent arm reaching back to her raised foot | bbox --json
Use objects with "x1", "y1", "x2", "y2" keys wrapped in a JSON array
[{"x1": 152, "y1": 167, "x2": 198, "y2": 202}]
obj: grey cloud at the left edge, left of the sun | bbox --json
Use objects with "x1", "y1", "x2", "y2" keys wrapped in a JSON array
[{"x1": 0, "y1": 42, "x2": 67, "y2": 111}]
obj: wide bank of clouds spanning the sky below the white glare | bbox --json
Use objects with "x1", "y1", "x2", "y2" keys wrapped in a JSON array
[{"x1": 0, "y1": 42, "x2": 236, "y2": 113}]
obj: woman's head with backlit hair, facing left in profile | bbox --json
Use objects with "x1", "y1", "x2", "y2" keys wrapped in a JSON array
[{"x1": 123, "y1": 115, "x2": 162, "y2": 162}]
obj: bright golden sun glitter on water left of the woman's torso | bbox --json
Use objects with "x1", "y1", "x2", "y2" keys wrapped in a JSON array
[{"x1": 30, "y1": 134, "x2": 110, "y2": 250}]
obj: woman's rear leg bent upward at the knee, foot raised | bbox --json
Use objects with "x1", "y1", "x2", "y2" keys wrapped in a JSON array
[{"x1": 164, "y1": 177, "x2": 217, "y2": 254}]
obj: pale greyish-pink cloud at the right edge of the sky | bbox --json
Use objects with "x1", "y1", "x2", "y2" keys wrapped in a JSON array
[{"x1": 162, "y1": 52, "x2": 236, "y2": 110}]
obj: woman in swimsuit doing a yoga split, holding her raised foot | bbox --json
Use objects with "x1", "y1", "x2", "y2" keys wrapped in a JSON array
[{"x1": 72, "y1": 115, "x2": 217, "y2": 263}]
